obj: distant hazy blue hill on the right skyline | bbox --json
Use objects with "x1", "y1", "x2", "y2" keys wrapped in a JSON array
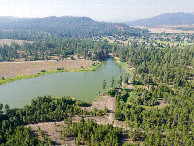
[{"x1": 126, "y1": 12, "x2": 194, "y2": 27}]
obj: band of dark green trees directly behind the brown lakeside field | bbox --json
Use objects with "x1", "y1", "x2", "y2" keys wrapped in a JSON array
[{"x1": 0, "y1": 38, "x2": 116, "y2": 61}]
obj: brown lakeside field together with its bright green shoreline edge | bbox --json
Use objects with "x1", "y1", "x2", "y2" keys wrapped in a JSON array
[{"x1": 0, "y1": 59, "x2": 101, "y2": 85}]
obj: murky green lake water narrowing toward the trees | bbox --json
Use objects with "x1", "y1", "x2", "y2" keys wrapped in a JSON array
[{"x1": 0, "y1": 59, "x2": 125, "y2": 108}]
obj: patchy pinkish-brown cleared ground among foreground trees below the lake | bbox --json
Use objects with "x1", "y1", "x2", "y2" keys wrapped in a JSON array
[{"x1": 27, "y1": 95, "x2": 124, "y2": 146}]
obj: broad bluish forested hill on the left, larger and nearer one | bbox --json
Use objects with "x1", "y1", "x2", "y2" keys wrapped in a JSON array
[{"x1": 0, "y1": 16, "x2": 146, "y2": 37}]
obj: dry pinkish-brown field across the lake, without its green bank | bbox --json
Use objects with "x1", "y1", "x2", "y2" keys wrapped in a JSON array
[{"x1": 0, "y1": 59, "x2": 94, "y2": 78}]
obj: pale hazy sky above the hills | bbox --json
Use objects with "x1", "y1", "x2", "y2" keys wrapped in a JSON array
[{"x1": 0, "y1": 0, "x2": 194, "y2": 21}]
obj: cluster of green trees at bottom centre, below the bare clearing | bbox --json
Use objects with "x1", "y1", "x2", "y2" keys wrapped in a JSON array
[{"x1": 61, "y1": 118, "x2": 123, "y2": 145}]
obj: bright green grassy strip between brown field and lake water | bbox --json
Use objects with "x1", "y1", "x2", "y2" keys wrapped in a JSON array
[{"x1": 0, "y1": 62, "x2": 102, "y2": 85}]
